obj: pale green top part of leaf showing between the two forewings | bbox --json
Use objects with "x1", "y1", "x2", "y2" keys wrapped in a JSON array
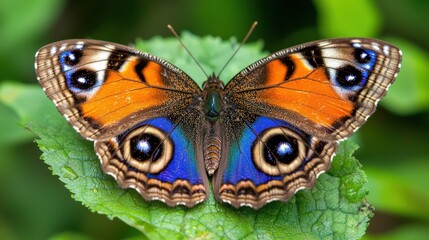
[{"x1": 135, "y1": 32, "x2": 268, "y2": 86}]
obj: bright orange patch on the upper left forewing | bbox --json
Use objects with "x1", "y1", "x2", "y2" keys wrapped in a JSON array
[{"x1": 81, "y1": 59, "x2": 168, "y2": 126}]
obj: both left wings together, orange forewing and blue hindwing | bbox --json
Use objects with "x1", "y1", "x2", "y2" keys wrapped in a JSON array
[{"x1": 35, "y1": 40, "x2": 208, "y2": 206}]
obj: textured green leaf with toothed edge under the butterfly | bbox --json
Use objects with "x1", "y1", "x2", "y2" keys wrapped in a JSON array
[{"x1": 26, "y1": 33, "x2": 372, "y2": 239}]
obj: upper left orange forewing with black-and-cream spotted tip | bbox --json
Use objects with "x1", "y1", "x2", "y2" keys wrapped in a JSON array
[{"x1": 35, "y1": 40, "x2": 201, "y2": 140}]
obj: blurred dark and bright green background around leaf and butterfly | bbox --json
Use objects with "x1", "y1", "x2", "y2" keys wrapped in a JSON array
[{"x1": 0, "y1": 0, "x2": 429, "y2": 239}]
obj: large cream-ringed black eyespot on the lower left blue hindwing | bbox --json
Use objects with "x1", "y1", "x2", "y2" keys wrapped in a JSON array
[{"x1": 119, "y1": 125, "x2": 174, "y2": 174}]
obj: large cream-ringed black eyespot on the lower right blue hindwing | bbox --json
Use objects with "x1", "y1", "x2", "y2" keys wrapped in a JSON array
[{"x1": 252, "y1": 127, "x2": 307, "y2": 176}]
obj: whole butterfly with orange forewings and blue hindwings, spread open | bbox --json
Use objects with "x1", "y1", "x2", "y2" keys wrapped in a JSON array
[{"x1": 35, "y1": 34, "x2": 401, "y2": 209}]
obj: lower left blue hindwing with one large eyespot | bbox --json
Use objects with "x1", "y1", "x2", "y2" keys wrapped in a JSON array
[{"x1": 95, "y1": 109, "x2": 209, "y2": 207}]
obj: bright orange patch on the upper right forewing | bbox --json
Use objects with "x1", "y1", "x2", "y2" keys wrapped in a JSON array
[{"x1": 258, "y1": 55, "x2": 354, "y2": 127}]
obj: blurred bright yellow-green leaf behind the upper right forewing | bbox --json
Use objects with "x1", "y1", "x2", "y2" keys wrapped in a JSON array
[{"x1": 314, "y1": 0, "x2": 380, "y2": 38}]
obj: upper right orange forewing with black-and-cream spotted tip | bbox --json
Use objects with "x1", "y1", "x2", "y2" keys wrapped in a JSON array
[{"x1": 226, "y1": 39, "x2": 401, "y2": 141}]
